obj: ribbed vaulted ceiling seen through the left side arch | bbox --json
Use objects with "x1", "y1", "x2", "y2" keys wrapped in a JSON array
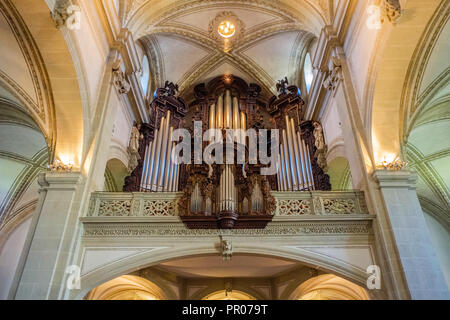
[{"x1": 0, "y1": 89, "x2": 48, "y2": 229}]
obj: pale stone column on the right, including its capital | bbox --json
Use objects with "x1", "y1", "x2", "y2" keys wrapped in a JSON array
[{"x1": 373, "y1": 170, "x2": 450, "y2": 299}]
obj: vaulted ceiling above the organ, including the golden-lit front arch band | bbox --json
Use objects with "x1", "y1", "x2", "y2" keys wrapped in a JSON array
[{"x1": 121, "y1": 0, "x2": 328, "y2": 96}]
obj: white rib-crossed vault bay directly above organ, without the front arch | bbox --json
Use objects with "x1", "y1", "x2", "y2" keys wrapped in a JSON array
[{"x1": 135, "y1": 1, "x2": 313, "y2": 95}]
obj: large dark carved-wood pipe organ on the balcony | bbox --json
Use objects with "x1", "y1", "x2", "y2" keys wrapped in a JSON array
[{"x1": 124, "y1": 75, "x2": 331, "y2": 228}]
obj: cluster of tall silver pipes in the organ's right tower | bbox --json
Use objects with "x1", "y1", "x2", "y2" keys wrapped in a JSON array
[{"x1": 277, "y1": 115, "x2": 314, "y2": 191}]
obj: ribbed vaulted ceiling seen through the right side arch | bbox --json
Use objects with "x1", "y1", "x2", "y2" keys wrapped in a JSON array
[{"x1": 403, "y1": 3, "x2": 450, "y2": 230}]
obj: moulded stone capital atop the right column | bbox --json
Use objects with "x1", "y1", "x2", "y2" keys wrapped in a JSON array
[{"x1": 373, "y1": 170, "x2": 418, "y2": 190}]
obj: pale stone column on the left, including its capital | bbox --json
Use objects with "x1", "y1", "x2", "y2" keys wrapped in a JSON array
[{"x1": 10, "y1": 172, "x2": 84, "y2": 300}]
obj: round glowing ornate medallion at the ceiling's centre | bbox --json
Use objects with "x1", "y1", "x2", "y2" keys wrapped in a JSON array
[{"x1": 209, "y1": 11, "x2": 244, "y2": 52}]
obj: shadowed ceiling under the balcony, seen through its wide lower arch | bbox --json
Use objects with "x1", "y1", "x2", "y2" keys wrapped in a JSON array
[{"x1": 158, "y1": 255, "x2": 301, "y2": 278}]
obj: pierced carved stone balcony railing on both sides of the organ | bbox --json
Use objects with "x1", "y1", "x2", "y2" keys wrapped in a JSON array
[{"x1": 86, "y1": 191, "x2": 368, "y2": 217}]
